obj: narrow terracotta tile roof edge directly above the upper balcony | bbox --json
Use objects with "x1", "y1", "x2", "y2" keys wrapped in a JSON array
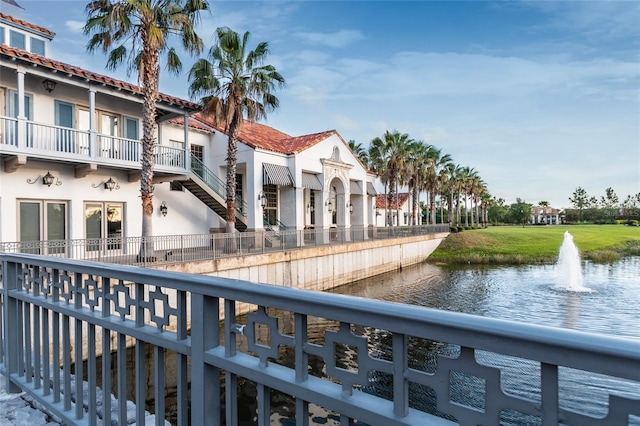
[{"x1": 0, "y1": 43, "x2": 200, "y2": 111}]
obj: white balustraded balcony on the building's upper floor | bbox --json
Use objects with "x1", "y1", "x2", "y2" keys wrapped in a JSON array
[{"x1": 0, "y1": 117, "x2": 188, "y2": 174}]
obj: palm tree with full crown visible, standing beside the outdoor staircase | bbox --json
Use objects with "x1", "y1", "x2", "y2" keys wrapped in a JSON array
[{"x1": 189, "y1": 27, "x2": 285, "y2": 233}]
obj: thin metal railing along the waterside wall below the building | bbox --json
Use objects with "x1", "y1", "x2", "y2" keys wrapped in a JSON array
[{"x1": 0, "y1": 225, "x2": 449, "y2": 266}]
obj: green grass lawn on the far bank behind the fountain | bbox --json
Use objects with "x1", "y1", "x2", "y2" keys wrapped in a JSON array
[{"x1": 429, "y1": 225, "x2": 640, "y2": 264}]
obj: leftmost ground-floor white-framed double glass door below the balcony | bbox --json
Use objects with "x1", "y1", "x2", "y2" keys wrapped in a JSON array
[{"x1": 18, "y1": 200, "x2": 67, "y2": 254}]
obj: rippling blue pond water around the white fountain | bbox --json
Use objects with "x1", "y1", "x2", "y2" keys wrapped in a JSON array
[{"x1": 334, "y1": 255, "x2": 640, "y2": 426}]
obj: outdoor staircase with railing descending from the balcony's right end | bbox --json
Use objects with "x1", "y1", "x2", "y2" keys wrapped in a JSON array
[{"x1": 180, "y1": 155, "x2": 247, "y2": 232}]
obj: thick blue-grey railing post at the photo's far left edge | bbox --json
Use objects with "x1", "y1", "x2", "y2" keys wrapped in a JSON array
[{"x1": 2, "y1": 262, "x2": 22, "y2": 393}]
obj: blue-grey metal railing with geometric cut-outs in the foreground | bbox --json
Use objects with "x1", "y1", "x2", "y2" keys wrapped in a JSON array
[{"x1": 0, "y1": 254, "x2": 640, "y2": 426}]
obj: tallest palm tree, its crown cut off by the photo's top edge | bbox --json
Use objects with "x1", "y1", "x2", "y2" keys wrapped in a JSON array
[{"x1": 84, "y1": 0, "x2": 209, "y2": 258}]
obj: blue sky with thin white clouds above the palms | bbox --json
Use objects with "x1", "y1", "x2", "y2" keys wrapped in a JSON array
[{"x1": 6, "y1": 0, "x2": 640, "y2": 208}]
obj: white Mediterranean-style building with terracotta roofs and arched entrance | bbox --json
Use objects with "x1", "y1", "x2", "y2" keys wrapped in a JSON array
[{"x1": 0, "y1": 8, "x2": 375, "y2": 251}]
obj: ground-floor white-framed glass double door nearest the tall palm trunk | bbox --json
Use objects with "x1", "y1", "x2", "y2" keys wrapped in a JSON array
[{"x1": 84, "y1": 202, "x2": 124, "y2": 252}]
